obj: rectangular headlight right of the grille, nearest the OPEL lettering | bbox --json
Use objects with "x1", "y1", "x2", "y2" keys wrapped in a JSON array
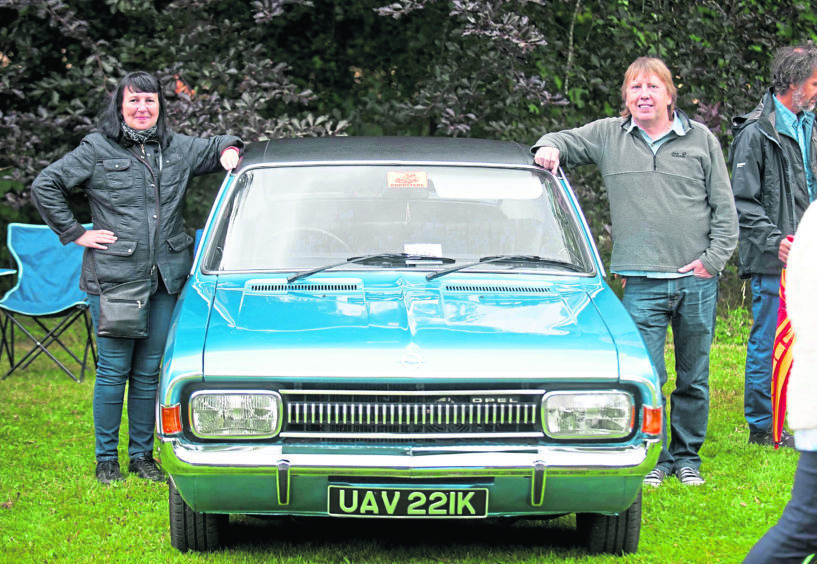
[{"x1": 542, "y1": 391, "x2": 635, "y2": 439}]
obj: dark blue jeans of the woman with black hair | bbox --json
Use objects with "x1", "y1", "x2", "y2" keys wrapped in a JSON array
[{"x1": 88, "y1": 283, "x2": 177, "y2": 462}]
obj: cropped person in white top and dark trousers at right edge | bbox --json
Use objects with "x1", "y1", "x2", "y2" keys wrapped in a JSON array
[{"x1": 744, "y1": 200, "x2": 817, "y2": 564}]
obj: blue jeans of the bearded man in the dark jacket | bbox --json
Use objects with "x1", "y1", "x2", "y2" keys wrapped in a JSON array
[{"x1": 743, "y1": 274, "x2": 780, "y2": 433}]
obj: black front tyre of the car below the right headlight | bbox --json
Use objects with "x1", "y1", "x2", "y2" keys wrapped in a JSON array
[{"x1": 576, "y1": 492, "x2": 641, "y2": 554}]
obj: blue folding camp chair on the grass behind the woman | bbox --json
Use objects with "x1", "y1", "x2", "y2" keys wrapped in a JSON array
[{"x1": 0, "y1": 223, "x2": 97, "y2": 382}]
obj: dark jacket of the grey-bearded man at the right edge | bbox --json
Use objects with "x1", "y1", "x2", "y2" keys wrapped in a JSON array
[{"x1": 729, "y1": 90, "x2": 817, "y2": 277}]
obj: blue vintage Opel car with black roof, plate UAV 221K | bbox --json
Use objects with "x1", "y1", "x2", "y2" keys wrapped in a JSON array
[{"x1": 157, "y1": 137, "x2": 662, "y2": 553}]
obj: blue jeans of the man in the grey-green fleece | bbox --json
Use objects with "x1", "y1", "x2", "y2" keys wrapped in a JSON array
[{"x1": 622, "y1": 276, "x2": 718, "y2": 473}]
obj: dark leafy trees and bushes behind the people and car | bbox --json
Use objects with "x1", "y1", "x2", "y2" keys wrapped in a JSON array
[{"x1": 0, "y1": 0, "x2": 817, "y2": 304}]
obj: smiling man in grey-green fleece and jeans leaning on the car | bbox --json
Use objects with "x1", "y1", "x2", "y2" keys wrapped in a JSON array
[{"x1": 531, "y1": 57, "x2": 738, "y2": 486}]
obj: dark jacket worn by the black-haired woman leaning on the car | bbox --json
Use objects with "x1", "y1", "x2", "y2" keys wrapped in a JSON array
[{"x1": 31, "y1": 132, "x2": 243, "y2": 294}]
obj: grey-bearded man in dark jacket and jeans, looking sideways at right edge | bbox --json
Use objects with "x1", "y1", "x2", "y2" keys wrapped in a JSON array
[{"x1": 729, "y1": 44, "x2": 817, "y2": 446}]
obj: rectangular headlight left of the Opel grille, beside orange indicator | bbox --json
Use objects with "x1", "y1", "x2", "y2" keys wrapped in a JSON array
[{"x1": 190, "y1": 390, "x2": 282, "y2": 439}]
